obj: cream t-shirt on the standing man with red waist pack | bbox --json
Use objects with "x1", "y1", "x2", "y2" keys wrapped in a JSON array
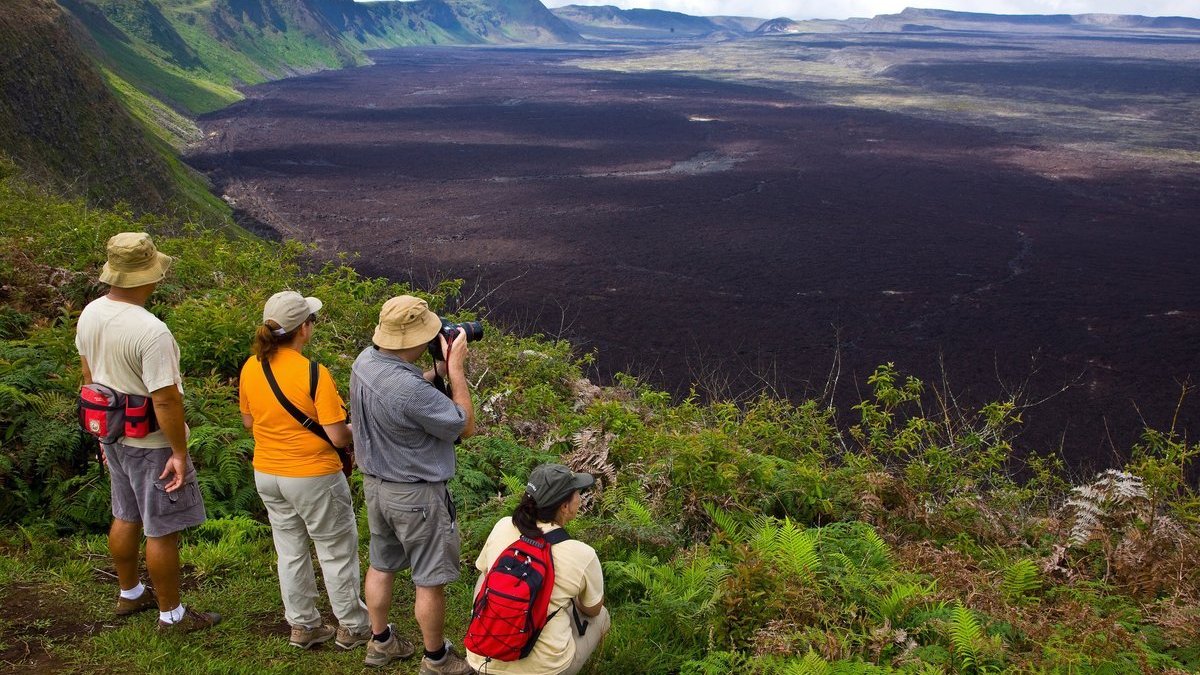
[{"x1": 76, "y1": 295, "x2": 184, "y2": 448}]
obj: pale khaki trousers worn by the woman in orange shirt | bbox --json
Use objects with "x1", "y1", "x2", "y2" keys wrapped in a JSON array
[{"x1": 254, "y1": 471, "x2": 371, "y2": 632}]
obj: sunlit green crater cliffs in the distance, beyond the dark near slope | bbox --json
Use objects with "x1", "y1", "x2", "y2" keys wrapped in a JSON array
[{"x1": 61, "y1": 0, "x2": 580, "y2": 113}]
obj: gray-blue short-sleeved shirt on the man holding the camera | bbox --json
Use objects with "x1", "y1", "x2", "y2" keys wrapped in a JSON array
[{"x1": 350, "y1": 346, "x2": 467, "y2": 483}]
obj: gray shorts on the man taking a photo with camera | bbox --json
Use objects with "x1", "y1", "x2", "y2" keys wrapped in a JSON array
[{"x1": 362, "y1": 476, "x2": 462, "y2": 586}]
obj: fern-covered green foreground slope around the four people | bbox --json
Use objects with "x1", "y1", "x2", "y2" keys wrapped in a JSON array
[{"x1": 0, "y1": 162, "x2": 1200, "y2": 675}]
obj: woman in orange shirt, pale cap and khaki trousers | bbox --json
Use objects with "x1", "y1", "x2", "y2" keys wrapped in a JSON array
[{"x1": 239, "y1": 291, "x2": 371, "y2": 650}]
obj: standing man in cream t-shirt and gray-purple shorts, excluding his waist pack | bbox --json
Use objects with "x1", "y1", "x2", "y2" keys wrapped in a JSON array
[{"x1": 76, "y1": 232, "x2": 221, "y2": 633}]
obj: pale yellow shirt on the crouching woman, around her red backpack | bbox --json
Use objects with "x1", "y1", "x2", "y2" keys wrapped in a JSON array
[{"x1": 467, "y1": 518, "x2": 604, "y2": 675}]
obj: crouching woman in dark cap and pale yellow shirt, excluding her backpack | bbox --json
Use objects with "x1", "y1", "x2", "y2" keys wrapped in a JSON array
[{"x1": 467, "y1": 464, "x2": 611, "y2": 675}]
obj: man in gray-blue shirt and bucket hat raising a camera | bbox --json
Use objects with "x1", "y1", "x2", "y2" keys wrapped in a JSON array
[{"x1": 350, "y1": 295, "x2": 475, "y2": 675}]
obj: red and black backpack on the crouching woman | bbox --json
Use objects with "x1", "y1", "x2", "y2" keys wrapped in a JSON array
[{"x1": 462, "y1": 528, "x2": 571, "y2": 661}]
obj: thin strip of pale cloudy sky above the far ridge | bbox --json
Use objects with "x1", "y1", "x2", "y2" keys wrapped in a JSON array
[{"x1": 542, "y1": 0, "x2": 1200, "y2": 19}]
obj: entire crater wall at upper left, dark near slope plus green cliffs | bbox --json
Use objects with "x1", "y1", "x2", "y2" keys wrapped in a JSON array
[{"x1": 0, "y1": 0, "x2": 581, "y2": 212}]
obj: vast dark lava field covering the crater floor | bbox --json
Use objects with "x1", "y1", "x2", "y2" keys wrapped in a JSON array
[{"x1": 190, "y1": 38, "x2": 1200, "y2": 467}]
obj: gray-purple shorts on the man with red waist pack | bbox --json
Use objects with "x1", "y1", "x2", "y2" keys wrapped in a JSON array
[{"x1": 104, "y1": 443, "x2": 204, "y2": 537}]
